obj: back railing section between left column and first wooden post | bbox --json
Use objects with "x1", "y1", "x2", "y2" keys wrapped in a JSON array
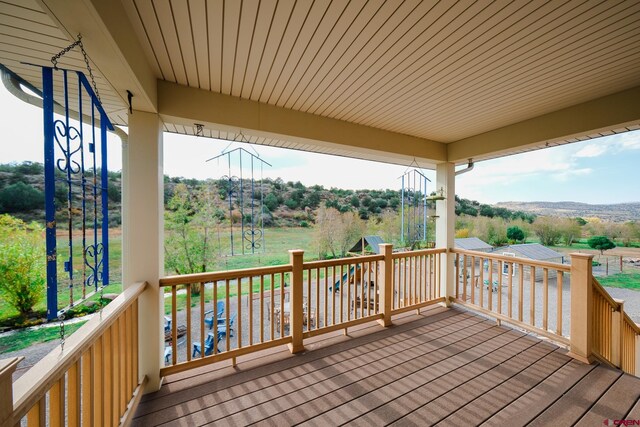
[{"x1": 160, "y1": 265, "x2": 292, "y2": 375}]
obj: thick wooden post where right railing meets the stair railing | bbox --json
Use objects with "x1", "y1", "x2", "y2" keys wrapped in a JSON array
[{"x1": 569, "y1": 253, "x2": 593, "y2": 363}]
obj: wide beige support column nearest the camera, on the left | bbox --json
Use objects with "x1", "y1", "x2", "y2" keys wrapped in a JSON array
[{"x1": 122, "y1": 111, "x2": 164, "y2": 393}]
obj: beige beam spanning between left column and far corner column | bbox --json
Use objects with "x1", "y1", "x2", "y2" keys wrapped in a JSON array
[{"x1": 158, "y1": 80, "x2": 446, "y2": 168}]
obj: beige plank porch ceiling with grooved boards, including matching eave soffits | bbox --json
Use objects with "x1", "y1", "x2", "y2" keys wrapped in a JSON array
[{"x1": 0, "y1": 0, "x2": 640, "y2": 160}]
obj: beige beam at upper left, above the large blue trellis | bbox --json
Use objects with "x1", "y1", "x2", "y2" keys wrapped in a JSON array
[{"x1": 39, "y1": 0, "x2": 157, "y2": 112}]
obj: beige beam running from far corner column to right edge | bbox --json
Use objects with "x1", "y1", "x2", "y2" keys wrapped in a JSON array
[{"x1": 447, "y1": 86, "x2": 640, "y2": 163}]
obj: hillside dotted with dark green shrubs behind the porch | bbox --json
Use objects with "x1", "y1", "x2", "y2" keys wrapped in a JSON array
[{"x1": 0, "y1": 162, "x2": 534, "y2": 227}]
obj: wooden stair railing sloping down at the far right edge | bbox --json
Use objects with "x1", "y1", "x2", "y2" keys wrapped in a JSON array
[{"x1": 592, "y1": 278, "x2": 640, "y2": 375}]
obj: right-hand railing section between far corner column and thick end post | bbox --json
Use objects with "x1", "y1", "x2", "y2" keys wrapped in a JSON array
[{"x1": 451, "y1": 249, "x2": 571, "y2": 345}]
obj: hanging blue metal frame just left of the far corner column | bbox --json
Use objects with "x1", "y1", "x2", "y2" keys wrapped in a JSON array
[{"x1": 400, "y1": 169, "x2": 431, "y2": 244}]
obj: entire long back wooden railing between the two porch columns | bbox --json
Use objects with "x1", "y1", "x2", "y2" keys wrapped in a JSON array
[{"x1": 160, "y1": 245, "x2": 446, "y2": 375}]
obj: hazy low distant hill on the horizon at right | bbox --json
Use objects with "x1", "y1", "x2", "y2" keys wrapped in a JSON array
[{"x1": 496, "y1": 202, "x2": 640, "y2": 222}]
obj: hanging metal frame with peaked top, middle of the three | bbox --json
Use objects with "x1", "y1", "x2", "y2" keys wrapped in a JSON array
[{"x1": 207, "y1": 148, "x2": 271, "y2": 256}]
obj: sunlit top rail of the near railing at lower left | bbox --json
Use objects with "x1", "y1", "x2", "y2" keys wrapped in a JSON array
[{"x1": 13, "y1": 282, "x2": 147, "y2": 420}]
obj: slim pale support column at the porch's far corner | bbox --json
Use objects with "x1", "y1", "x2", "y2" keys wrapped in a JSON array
[{"x1": 436, "y1": 163, "x2": 456, "y2": 305}]
